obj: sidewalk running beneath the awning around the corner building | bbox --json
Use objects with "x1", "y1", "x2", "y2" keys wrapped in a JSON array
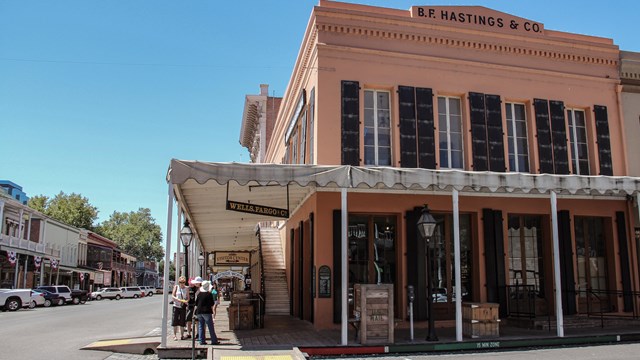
[{"x1": 125, "y1": 301, "x2": 640, "y2": 360}]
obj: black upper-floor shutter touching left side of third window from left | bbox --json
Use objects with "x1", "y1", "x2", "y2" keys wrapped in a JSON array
[{"x1": 484, "y1": 94, "x2": 506, "y2": 172}]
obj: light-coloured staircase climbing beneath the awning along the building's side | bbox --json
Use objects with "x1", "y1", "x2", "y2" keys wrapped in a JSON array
[{"x1": 260, "y1": 227, "x2": 290, "y2": 315}]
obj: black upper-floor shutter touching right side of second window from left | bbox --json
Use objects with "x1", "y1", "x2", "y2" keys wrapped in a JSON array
[{"x1": 469, "y1": 92, "x2": 489, "y2": 171}]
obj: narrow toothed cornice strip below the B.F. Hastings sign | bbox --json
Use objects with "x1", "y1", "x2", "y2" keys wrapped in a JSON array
[{"x1": 316, "y1": 23, "x2": 619, "y2": 66}]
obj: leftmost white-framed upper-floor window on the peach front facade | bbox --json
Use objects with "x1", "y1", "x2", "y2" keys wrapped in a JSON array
[{"x1": 364, "y1": 90, "x2": 391, "y2": 166}]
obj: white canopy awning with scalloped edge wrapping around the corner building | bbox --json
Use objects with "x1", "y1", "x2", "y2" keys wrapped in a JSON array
[{"x1": 167, "y1": 159, "x2": 640, "y2": 255}]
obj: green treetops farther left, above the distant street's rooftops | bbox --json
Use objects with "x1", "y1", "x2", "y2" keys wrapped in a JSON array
[{"x1": 28, "y1": 191, "x2": 98, "y2": 230}]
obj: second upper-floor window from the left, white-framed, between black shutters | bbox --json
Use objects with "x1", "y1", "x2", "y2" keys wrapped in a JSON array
[{"x1": 438, "y1": 96, "x2": 464, "y2": 169}]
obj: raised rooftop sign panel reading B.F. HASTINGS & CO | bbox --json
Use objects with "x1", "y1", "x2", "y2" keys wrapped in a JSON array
[{"x1": 411, "y1": 6, "x2": 544, "y2": 34}]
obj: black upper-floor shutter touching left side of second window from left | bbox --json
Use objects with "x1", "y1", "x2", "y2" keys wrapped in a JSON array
[{"x1": 416, "y1": 88, "x2": 436, "y2": 169}]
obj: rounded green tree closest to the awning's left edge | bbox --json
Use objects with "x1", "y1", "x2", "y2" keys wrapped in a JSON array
[{"x1": 96, "y1": 208, "x2": 164, "y2": 261}]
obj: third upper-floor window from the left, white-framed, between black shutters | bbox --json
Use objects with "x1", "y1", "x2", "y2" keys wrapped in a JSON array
[{"x1": 506, "y1": 103, "x2": 529, "y2": 172}]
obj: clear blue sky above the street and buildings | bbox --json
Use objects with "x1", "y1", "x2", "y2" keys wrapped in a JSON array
[{"x1": 0, "y1": 0, "x2": 640, "y2": 249}]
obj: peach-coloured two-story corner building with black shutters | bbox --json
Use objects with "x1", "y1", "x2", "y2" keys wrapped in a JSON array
[{"x1": 170, "y1": 0, "x2": 640, "y2": 339}]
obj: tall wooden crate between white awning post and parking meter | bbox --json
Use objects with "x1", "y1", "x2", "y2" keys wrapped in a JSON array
[{"x1": 354, "y1": 284, "x2": 395, "y2": 344}]
